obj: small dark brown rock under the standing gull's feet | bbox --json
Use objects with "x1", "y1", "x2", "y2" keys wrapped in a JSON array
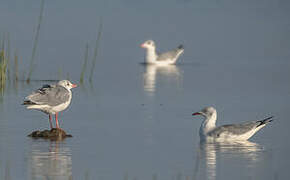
[{"x1": 28, "y1": 128, "x2": 72, "y2": 140}]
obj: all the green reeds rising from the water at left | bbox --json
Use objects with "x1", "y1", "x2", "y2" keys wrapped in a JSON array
[{"x1": 0, "y1": 0, "x2": 103, "y2": 95}]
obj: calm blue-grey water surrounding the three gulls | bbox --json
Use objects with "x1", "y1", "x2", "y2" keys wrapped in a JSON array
[{"x1": 0, "y1": 0, "x2": 290, "y2": 180}]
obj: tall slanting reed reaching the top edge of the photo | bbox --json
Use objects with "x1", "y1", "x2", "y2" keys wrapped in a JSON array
[{"x1": 26, "y1": 0, "x2": 44, "y2": 83}]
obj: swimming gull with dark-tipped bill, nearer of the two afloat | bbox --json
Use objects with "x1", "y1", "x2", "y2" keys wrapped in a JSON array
[{"x1": 192, "y1": 107, "x2": 273, "y2": 141}]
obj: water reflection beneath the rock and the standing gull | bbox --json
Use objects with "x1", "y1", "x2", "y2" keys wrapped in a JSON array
[{"x1": 28, "y1": 140, "x2": 72, "y2": 180}]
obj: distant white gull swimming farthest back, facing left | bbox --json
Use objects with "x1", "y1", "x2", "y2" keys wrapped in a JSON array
[{"x1": 141, "y1": 40, "x2": 184, "y2": 65}]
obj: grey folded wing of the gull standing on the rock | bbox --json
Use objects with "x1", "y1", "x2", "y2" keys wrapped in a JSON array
[{"x1": 24, "y1": 85, "x2": 70, "y2": 106}]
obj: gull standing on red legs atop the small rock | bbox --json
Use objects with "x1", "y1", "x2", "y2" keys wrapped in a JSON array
[{"x1": 23, "y1": 80, "x2": 77, "y2": 129}]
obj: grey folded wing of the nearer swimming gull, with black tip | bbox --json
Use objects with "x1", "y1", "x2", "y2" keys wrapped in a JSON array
[{"x1": 208, "y1": 116, "x2": 273, "y2": 138}]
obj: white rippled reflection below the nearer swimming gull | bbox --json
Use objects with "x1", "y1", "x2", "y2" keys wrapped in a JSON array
[{"x1": 199, "y1": 141, "x2": 263, "y2": 180}]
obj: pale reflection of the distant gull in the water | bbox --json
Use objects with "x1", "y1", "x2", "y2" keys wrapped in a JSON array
[{"x1": 143, "y1": 65, "x2": 181, "y2": 96}]
